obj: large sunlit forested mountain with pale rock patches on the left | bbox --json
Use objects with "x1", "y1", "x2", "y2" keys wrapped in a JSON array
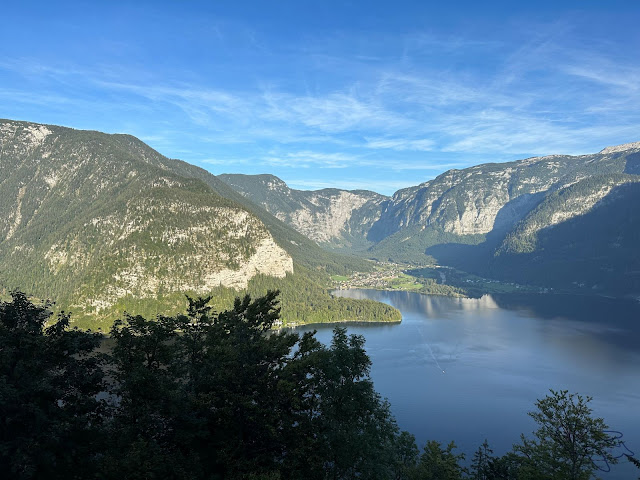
[{"x1": 0, "y1": 120, "x2": 393, "y2": 321}]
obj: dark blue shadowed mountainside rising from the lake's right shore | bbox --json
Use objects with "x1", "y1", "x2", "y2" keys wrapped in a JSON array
[{"x1": 489, "y1": 183, "x2": 640, "y2": 295}]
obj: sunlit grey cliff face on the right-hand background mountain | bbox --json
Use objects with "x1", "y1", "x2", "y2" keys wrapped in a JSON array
[{"x1": 374, "y1": 152, "x2": 625, "y2": 237}]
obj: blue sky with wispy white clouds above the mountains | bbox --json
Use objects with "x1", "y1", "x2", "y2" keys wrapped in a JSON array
[{"x1": 0, "y1": 0, "x2": 640, "y2": 195}]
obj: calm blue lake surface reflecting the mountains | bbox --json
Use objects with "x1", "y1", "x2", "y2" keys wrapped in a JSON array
[{"x1": 296, "y1": 290, "x2": 640, "y2": 480}]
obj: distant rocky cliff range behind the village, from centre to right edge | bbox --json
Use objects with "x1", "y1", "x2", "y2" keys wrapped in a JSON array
[{"x1": 220, "y1": 143, "x2": 640, "y2": 280}]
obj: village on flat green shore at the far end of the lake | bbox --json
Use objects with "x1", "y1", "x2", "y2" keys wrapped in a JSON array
[{"x1": 331, "y1": 262, "x2": 553, "y2": 297}]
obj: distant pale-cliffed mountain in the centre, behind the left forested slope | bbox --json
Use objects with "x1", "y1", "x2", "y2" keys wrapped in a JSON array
[{"x1": 218, "y1": 174, "x2": 389, "y2": 251}]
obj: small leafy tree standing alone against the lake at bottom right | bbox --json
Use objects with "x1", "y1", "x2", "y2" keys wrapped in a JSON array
[{"x1": 514, "y1": 390, "x2": 619, "y2": 480}]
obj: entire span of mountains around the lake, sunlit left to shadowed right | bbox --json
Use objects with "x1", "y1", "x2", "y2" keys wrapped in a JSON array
[{"x1": 0, "y1": 120, "x2": 640, "y2": 325}]
